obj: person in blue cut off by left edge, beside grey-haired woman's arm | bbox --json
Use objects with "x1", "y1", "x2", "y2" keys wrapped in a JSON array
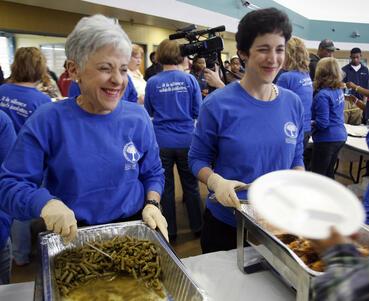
[{"x1": 0, "y1": 111, "x2": 16, "y2": 285}]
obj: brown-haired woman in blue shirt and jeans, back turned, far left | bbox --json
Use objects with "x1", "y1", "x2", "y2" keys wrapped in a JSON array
[{"x1": 0, "y1": 47, "x2": 51, "y2": 266}]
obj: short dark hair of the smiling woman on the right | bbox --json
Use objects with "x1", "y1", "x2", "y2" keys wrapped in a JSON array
[{"x1": 236, "y1": 7, "x2": 292, "y2": 55}]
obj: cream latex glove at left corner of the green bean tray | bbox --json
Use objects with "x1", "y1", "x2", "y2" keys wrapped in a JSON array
[{"x1": 40, "y1": 199, "x2": 77, "y2": 242}]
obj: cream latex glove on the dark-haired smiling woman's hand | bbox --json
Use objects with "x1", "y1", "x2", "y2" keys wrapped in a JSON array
[{"x1": 207, "y1": 173, "x2": 246, "y2": 209}]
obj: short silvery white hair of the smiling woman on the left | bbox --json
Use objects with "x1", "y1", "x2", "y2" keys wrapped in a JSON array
[{"x1": 65, "y1": 15, "x2": 132, "y2": 68}]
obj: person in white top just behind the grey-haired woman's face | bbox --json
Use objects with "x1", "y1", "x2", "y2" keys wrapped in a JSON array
[{"x1": 128, "y1": 44, "x2": 146, "y2": 104}]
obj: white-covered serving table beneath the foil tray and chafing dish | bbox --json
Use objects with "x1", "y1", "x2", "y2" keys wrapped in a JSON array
[{"x1": 0, "y1": 250, "x2": 296, "y2": 301}]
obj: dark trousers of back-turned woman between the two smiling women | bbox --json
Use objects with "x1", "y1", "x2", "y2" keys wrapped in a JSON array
[{"x1": 160, "y1": 148, "x2": 202, "y2": 235}]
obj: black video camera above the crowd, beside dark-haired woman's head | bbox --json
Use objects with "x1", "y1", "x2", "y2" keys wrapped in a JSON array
[{"x1": 169, "y1": 25, "x2": 225, "y2": 68}]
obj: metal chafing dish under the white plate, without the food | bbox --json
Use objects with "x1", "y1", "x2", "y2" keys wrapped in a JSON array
[{"x1": 236, "y1": 204, "x2": 369, "y2": 301}]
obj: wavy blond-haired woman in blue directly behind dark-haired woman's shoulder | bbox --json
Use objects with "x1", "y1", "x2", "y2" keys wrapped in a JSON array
[{"x1": 277, "y1": 37, "x2": 313, "y2": 161}]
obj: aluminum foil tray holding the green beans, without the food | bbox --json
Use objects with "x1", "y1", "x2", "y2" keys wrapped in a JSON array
[{"x1": 40, "y1": 221, "x2": 208, "y2": 301}]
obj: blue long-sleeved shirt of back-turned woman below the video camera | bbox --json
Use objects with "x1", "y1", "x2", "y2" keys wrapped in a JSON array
[{"x1": 145, "y1": 70, "x2": 202, "y2": 148}]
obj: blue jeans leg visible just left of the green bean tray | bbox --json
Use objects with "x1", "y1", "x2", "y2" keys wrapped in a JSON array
[{"x1": 11, "y1": 220, "x2": 32, "y2": 265}]
